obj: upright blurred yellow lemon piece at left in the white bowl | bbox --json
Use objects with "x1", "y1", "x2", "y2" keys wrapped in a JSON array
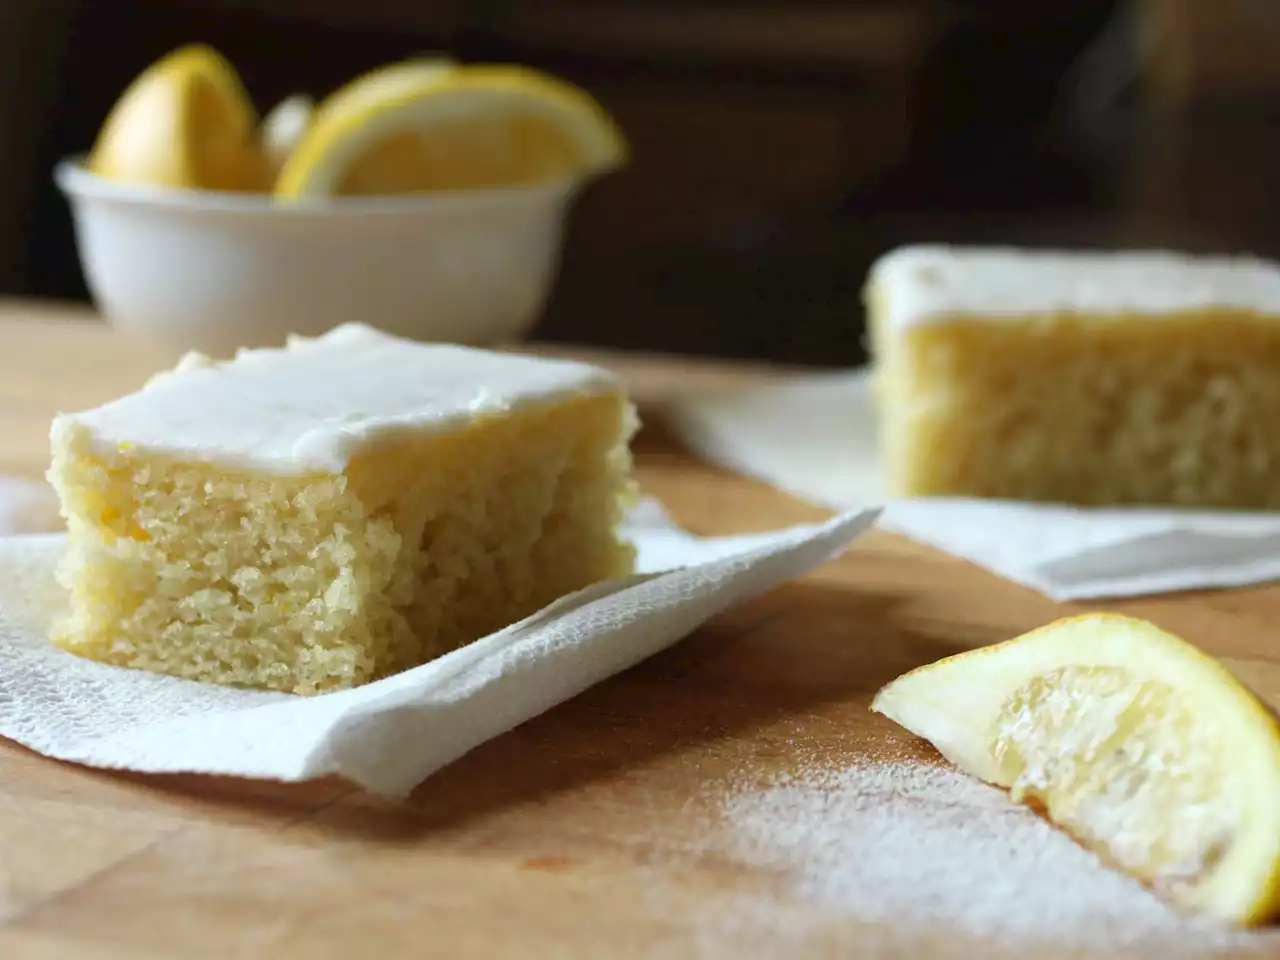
[{"x1": 87, "y1": 44, "x2": 270, "y2": 191}]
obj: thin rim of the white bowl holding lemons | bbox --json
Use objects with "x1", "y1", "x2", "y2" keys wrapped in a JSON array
[{"x1": 54, "y1": 154, "x2": 590, "y2": 219}]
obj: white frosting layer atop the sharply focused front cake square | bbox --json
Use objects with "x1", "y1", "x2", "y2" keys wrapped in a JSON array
[{"x1": 54, "y1": 324, "x2": 622, "y2": 474}]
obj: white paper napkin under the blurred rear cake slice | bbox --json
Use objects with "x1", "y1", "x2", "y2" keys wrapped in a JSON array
[{"x1": 664, "y1": 371, "x2": 1280, "y2": 600}]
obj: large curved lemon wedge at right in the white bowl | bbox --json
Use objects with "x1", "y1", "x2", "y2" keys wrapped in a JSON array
[{"x1": 275, "y1": 64, "x2": 626, "y2": 200}]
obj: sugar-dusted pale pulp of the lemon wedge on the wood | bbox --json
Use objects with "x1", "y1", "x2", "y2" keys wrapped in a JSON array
[{"x1": 992, "y1": 667, "x2": 1242, "y2": 892}]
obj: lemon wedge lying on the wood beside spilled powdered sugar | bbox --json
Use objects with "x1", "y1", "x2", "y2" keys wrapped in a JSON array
[{"x1": 872, "y1": 613, "x2": 1280, "y2": 924}]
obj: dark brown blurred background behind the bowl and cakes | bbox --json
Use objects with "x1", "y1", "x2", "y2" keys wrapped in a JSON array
[{"x1": 0, "y1": 0, "x2": 1280, "y2": 365}]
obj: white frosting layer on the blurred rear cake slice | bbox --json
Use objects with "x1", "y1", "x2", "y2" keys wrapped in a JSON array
[{"x1": 869, "y1": 246, "x2": 1280, "y2": 329}]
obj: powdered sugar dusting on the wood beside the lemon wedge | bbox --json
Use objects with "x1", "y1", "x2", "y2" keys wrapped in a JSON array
[{"x1": 716, "y1": 762, "x2": 1277, "y2": 956}]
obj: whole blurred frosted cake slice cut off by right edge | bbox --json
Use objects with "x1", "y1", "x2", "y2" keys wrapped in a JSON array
[{"x1": 865, "y1": 246, "x2": 1280, "y2": 508}]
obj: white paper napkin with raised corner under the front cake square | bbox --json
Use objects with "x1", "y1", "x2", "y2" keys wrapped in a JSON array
[{"x1": 0, "y1": 503, "x2": 877, "y2": 796}]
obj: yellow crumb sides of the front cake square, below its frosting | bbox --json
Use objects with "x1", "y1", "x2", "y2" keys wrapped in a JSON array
[{"x1": 50, "y1": 390, "x2": 636, "y2": 694}]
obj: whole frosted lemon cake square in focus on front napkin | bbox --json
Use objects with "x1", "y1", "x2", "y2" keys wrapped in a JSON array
[{"x1": 49, "y1": 325, "x2": 636, "y2": 694}]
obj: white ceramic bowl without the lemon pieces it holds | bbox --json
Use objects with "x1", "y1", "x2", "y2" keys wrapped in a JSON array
[{"x1": 55, "y1": 159, "x2": 579, "y2": 356}]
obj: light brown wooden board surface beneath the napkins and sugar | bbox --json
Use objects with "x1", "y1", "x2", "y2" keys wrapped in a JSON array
[{"x1": 0, "y1": 303, "x2": 1280, "y2": 960}]
